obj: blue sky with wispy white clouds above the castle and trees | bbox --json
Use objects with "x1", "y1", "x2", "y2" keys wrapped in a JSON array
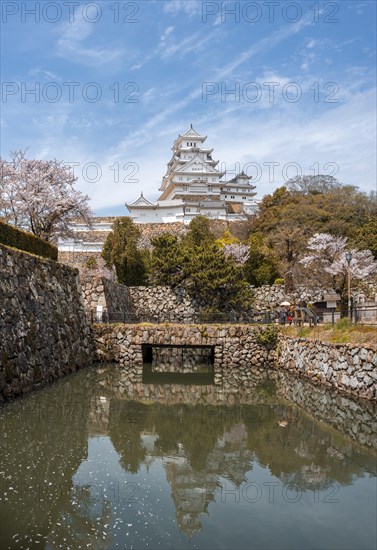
[{"x1": 1, "y1": 0, "x2": 376, "y2": 215}]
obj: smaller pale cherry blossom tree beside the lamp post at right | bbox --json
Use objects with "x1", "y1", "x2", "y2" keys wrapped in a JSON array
[{"x1": 300, "y1": 233, "x2": 377, "y2": 297}]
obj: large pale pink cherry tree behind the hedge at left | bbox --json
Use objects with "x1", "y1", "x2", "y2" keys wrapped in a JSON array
[{"x1": 0, "y1": 150, "x2": 92, "y2": 241}]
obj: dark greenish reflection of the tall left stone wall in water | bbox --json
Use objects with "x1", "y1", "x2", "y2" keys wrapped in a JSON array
[{"x1": 0, "y1": 371, "x2": 91, "y2": 548}]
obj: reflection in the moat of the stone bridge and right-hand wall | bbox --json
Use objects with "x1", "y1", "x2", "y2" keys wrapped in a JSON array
[{"x1": 91, "y1": 365, "x2": 377, "y2": 449}]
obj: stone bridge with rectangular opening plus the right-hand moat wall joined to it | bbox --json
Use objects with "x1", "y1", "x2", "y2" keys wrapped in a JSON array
[{"x1": 93, "y1": 324, "x2": 377, "y2": 401}]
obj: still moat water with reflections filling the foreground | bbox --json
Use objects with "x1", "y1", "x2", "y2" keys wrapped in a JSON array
[{"x1": 0, "y1": 365, "x2": 377, "y2": 550}]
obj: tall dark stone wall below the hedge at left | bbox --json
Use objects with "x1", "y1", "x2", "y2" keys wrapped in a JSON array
[{"x1": 0, "y1": 245, "x2": 93, "y2": 400}]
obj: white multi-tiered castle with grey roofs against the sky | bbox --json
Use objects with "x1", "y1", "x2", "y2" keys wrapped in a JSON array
[{"x1": 126, "y1": 124, "x2": 257, "y2": 223}]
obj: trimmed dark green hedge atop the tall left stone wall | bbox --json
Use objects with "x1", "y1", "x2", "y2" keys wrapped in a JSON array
[{"x1": 0, "y1": 220, "x2": 58, "y2": 261}]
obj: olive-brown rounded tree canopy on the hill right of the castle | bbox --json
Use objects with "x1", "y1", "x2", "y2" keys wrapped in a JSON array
[{"x1": 250, "y1": 181, "x2": 377, "y2": 274}]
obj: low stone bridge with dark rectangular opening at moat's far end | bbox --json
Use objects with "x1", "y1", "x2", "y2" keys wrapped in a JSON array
[{"x1": 93, "y1": 324, "x2": 277, "y2": 387}]
